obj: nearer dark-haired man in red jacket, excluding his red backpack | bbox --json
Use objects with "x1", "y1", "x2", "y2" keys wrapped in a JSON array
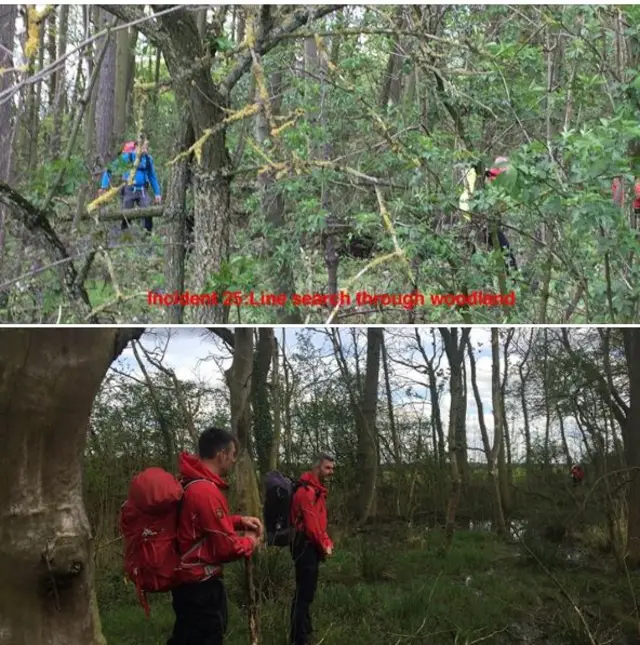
[{"x1": 167, "y1": 427, "x2": 264, "y2": 645}]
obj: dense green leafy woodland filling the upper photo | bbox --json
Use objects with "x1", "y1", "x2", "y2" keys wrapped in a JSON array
[{"x1": 0, "y1": 4, "x2": 640, "y2": 324}]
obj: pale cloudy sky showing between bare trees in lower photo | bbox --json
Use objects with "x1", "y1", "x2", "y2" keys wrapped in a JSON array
[{"x1": 115, "y1": 327, "x2": 579, "y2": 460}]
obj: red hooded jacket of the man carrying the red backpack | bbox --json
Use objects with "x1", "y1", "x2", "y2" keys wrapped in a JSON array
[{"x1": 177, "y1": 452, "x2": 254, "y2": 583}]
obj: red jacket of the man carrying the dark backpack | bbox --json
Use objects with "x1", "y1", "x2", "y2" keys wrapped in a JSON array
[{"x1": 290, "y1": 472, "x2": 333, "y2": 552}]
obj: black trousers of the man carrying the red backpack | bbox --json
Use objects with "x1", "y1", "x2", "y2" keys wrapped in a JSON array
[{"x1": 167, "y1": 577, "x2": 228, "y2": 645}]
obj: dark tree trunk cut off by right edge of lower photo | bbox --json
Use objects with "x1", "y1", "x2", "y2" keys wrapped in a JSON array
[{"x1": 622, "y1": 328, "x2": 640, "y2": 567}]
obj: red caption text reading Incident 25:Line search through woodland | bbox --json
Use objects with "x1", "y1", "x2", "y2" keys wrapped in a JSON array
[{"x1": 147, "y1": 291, "x2": 516, "y2": 309}]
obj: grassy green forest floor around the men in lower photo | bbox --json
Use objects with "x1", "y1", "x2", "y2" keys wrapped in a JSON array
[{"x1": 98, "y1": 523, "x2": 640, "y2": 645}]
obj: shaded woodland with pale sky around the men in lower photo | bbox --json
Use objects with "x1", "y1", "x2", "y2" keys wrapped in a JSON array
[{"x1": 0, "y1": 327, "x2": 640, "y2": 645}]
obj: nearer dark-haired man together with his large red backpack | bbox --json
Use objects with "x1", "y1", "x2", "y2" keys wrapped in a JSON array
[{"x1": 120, "y1": 427, "x2": 264, "y2": 645}]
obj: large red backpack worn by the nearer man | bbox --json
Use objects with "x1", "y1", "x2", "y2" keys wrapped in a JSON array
[{"x1": 120, "y1": 467, "x2": 202, "y2": 616}]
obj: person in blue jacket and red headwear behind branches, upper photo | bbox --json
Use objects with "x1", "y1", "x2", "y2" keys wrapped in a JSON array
[{"x1": 100, "y1": 140, "x2": 162, "y2": 232}]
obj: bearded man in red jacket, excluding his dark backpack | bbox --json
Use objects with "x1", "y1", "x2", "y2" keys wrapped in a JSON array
[{"x1": 290, "y1": 455, "x2": 335, "y2": 645}]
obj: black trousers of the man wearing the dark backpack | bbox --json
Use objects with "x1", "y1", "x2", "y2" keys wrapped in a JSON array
[{"x1": 291, "y1": 533, "x2": 321, "y2": 645}]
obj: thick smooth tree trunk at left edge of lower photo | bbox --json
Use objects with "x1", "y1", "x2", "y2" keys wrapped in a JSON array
[{"x1": 0, "y1": 329, "x2": 142, "y2": 645}]
